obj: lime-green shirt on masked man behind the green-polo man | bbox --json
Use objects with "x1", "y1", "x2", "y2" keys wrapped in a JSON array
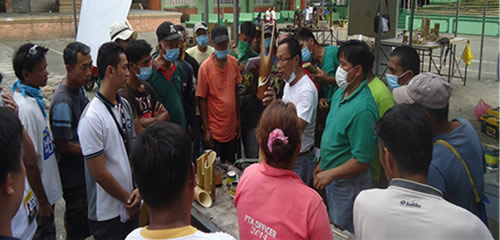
[{"x1": 368, "y1": 77, "x2": 396, "y2": 181}]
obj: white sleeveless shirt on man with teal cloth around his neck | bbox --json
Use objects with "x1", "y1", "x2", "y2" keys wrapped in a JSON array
[{"x1": 14, "y1": 91, "x2": 62, "y2": 205}]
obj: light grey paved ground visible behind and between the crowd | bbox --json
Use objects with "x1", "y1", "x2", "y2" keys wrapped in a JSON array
[{"x1": 0, "y1": 27, "x2": 499, "y2": 239}]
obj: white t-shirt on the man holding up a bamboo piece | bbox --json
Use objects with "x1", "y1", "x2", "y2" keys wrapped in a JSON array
[{"x1": 283, "y1": 74, "x2": 318, "y2": 152}]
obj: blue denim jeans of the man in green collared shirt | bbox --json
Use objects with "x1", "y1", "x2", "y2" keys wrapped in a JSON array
[{"x1": 326, "y1": 169, "x2": 372, "y2": 233}]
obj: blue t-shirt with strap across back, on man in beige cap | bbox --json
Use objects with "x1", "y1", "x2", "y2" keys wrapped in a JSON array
[{"x1": 427, "y1": 118, "x2": 486, "y2": 220}]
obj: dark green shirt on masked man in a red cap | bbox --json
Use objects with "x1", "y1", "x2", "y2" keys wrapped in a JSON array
[{"x1": 147, "y1": 58, "x2": 187, "y2": 129}]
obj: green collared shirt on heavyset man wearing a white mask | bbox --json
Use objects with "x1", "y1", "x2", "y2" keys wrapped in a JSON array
[{"x1": 320, "y1": 80, "x2": 378, "y2": 170}]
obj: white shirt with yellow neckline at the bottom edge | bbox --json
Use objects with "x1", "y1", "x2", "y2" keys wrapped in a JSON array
[{"x1": 125, "y1": 226, "x2": 235, "y2": 240}]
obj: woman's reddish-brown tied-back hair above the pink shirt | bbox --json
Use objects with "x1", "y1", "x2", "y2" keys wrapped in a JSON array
[{"x1": 256, "y1": 100, "x2": 300, "y2": 164}]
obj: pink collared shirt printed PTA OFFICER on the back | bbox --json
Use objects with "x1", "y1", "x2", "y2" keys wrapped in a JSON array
[{"x1": 234, "y1": 161, "x2": 333, "y2": 240}]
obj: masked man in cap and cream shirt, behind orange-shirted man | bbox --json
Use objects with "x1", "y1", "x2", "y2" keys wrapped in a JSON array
[{"x1": 186, "y1": 22, "x2": 214, "y2": 65}]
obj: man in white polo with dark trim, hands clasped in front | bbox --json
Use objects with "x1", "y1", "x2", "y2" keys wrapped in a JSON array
[{"x1": 78, "y1": 42, "x2": 141, "y2": 240}]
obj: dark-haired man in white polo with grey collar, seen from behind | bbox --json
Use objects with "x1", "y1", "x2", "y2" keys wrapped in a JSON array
[{"x1": 354, "y1": 104, "x2": 493, "y2": 239}]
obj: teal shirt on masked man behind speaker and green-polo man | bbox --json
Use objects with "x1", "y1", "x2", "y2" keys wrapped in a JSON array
[{"x1": 320, "y1": 46, "x2": 339, "y2": 104}]
